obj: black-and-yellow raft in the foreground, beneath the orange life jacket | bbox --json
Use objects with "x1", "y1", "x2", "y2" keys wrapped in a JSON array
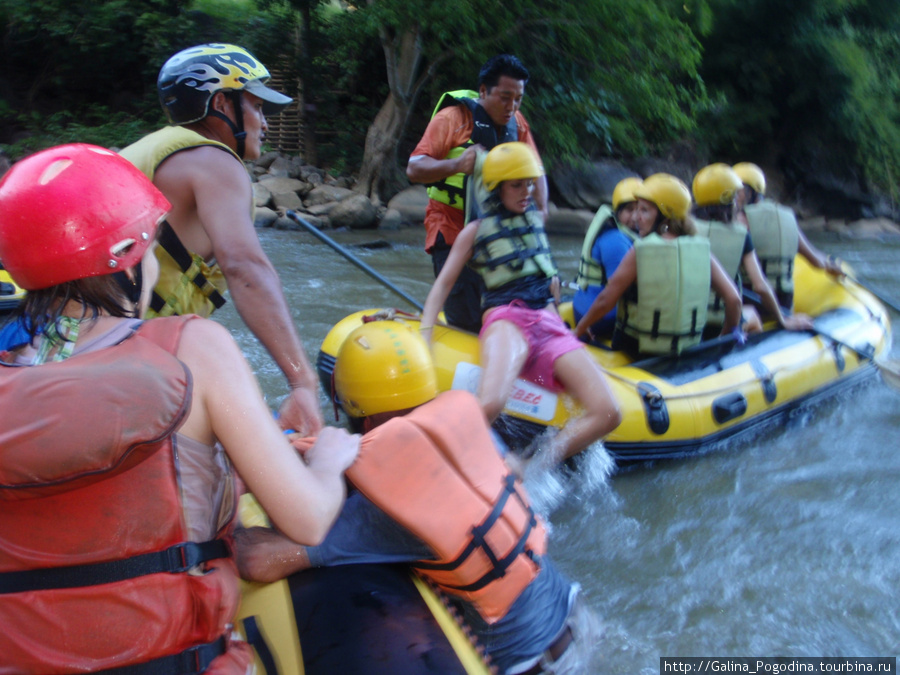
[{"x1": 237, "y1": 495, "x2": 490, "y2": 675}]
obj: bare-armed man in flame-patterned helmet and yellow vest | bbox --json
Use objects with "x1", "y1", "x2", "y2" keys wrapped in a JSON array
[{"x1": 122, "y1": 44, "x2": 323, "y2": 433}]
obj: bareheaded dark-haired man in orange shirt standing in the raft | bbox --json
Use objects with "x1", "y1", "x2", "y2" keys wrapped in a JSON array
[{"x1": 406, "y1": 54, "x2": 547, "y2": 333}]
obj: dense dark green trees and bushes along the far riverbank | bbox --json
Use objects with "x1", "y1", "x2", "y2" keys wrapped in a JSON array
[{"x1": 0, "y1": 0, "x2": 900, "y2": 211}]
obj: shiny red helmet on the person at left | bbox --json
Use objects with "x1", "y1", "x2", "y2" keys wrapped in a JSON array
[{"x1": 0, "y1": 143, "x2": 171, "y2": 290}]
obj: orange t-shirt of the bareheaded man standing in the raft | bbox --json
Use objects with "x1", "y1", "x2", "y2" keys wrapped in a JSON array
[{"x1": 410, "y1": 105, "x2": 540, "y2": 253}]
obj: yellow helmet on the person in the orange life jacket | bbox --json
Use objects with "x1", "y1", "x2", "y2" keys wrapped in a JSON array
[{"x1": 334, "y1": 321, "x2": 438, "y2": 418}]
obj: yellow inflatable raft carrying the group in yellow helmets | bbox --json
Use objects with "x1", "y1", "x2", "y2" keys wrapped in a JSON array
[{"x1": 317, "y1": 256, "x2": 891, "y2": 463}]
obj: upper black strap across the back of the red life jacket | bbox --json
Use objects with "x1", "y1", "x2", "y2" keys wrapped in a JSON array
[{"x1": 0, "y1": 539, "x2": 230, "y2": 594}]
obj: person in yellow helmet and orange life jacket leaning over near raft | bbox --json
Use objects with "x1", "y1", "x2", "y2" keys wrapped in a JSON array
[{"x1": 235, "y1": 321, "x2": 597, "y2": 674}]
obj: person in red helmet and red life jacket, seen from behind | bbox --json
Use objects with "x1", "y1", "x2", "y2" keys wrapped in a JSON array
[{"x1": 0, "y1": 144, "x2": 358, "y2": 675}]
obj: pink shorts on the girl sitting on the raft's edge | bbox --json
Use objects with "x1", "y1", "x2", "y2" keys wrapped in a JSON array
[{"x1": 478, "y1": 302, "x2": 584, "y2": 391}]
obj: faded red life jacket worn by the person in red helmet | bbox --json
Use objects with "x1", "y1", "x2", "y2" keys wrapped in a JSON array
[{"x1": 0, "y1": 317, "x2": 247, "y2": 673}]
